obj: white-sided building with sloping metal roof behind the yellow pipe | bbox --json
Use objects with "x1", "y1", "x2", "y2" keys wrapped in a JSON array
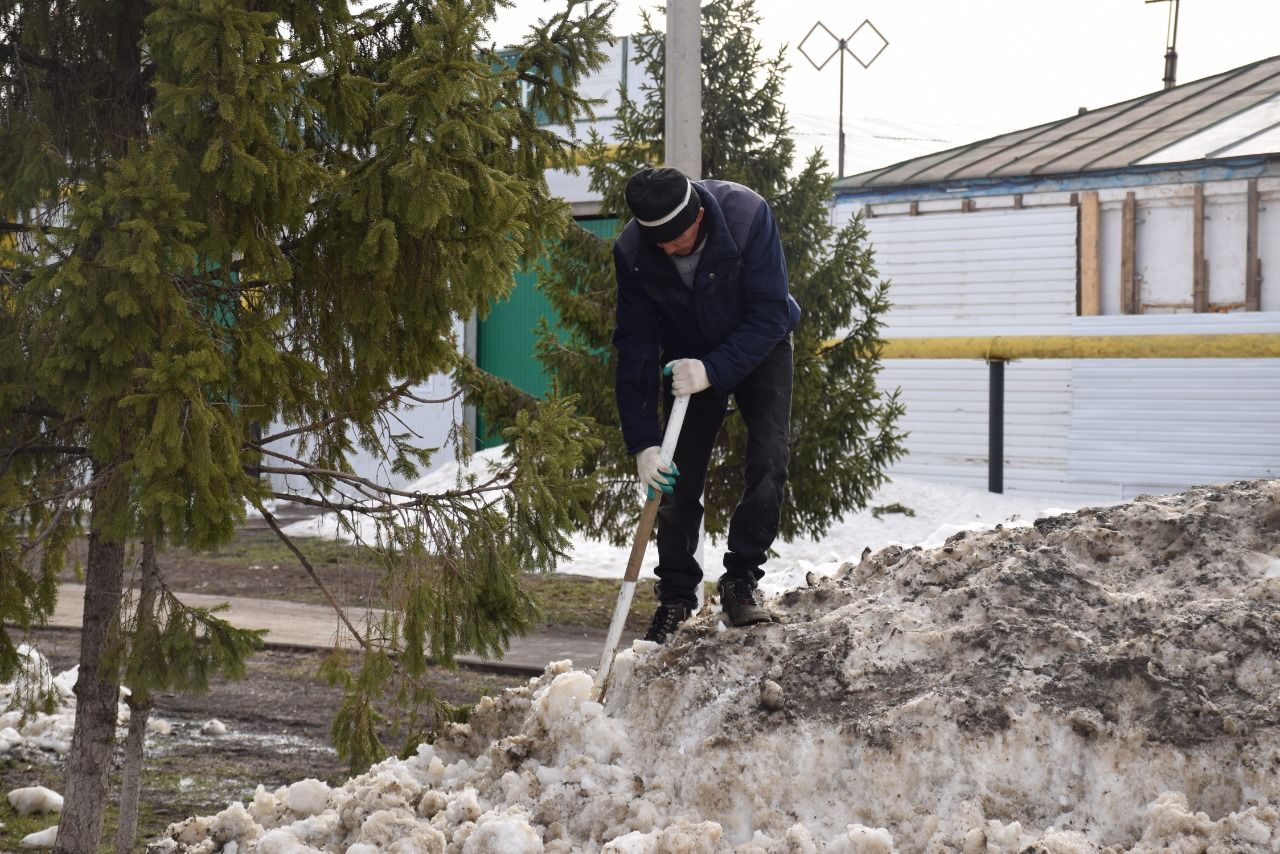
[{"x1": 829, "y1": 56, "x2": 1280, "y2": 501}]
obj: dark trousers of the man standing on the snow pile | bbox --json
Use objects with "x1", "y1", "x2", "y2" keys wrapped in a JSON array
[{"x1": 654, "y1": 335, "x2": 791, "y2": 607}]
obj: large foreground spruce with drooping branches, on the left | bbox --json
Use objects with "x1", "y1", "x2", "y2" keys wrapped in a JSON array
[{"x1": 0, "y1": 0, "x2": 609, "y2": 851}]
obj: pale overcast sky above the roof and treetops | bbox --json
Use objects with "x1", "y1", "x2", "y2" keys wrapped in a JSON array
[{"x1": 494, "y1": 0, "x2": 1280, "y2": 174}]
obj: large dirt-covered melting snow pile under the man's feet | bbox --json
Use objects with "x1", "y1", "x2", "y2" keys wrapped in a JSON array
[{"x1": 152, "y1": 481, "x2": 1280, "y2": 854}]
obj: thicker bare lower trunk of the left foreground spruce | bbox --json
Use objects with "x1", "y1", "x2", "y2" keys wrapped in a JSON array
[{"x1": 54, "y1": 486, "x2": 124, "y2": 854}]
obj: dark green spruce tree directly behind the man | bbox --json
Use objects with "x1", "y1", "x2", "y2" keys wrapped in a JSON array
[{"x1": 524, "y1": 0, "x2": 904, "y2": 542}]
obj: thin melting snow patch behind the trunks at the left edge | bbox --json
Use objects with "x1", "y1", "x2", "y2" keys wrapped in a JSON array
[{"x1": 0, "y1": 644, "x2": 172, "y2": 755}]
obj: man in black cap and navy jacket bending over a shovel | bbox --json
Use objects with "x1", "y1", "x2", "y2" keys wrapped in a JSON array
[{"x1": 613, "y1": 169, "x2": 800, "y2": 643}]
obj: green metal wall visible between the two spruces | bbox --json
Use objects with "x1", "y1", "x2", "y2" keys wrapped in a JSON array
[{"x1": 476, "y1": 218, "x2": 618, "y2": 448}]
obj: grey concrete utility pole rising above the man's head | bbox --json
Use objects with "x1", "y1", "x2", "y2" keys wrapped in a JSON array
[{"x1": 663, "y1": 0, "x2": 703, "y2": 181}]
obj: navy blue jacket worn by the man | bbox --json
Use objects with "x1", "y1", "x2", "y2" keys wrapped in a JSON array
[{"x1": 613, "y1": 181, "x2": 800, "y2": 453}]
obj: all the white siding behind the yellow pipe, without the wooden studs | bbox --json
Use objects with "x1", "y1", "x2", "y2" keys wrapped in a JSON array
[{"x1": 836, "y1": 205, "x2": 1280, "y2": 501}]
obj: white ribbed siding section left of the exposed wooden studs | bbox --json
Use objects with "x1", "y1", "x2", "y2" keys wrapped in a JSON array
[{"x1": 846, "y1": 207, "x2": 1076, "y2": 494}]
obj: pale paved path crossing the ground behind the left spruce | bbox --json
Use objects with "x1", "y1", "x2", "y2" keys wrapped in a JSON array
[{"x1": 49, "y1": 584, "x2": 640, "y2": 675}]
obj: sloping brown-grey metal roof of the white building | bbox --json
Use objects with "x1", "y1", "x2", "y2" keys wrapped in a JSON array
[{"x1": 835, "y1": 56, "x2": 1280, "y2": 191}]
